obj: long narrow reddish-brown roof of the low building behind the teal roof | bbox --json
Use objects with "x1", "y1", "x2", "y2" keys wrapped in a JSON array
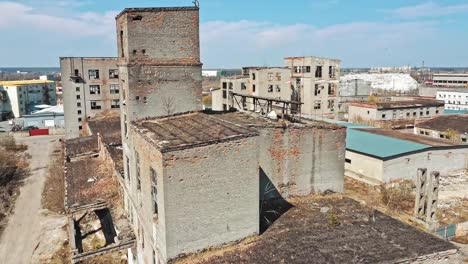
[{"x1": 351, "y1": 99, "x2": 445, "y2": 110}]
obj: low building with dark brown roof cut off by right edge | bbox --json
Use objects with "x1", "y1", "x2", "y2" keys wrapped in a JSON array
[{"x1": 414, "y1": 115, "x2": 468, "y2": 144}]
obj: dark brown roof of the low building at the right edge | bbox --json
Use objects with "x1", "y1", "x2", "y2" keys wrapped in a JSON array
[{"x1": 416, "y1": 115, "x2": 468, "y2": 134}]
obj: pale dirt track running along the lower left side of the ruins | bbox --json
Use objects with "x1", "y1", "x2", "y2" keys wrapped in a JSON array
[{"x1": 0, "y1": 136, "x2": 67, "y2": 264}]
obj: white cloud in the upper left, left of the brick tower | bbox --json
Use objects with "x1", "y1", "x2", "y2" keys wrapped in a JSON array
[{"x1": 0, "y1": 2, "x2": 117, "y2": 39}]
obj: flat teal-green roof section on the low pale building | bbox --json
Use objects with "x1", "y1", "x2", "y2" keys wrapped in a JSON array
[{"x1": 346, "y1": 128, "x2": 431, "y2": 159}]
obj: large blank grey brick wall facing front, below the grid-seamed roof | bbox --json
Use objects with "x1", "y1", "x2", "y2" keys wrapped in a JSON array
[{"x1": 164, "y1": 137, "x2": 259, "y2": 259}]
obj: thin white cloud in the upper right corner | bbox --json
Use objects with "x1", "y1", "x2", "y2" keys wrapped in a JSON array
[{"x1": 387, "y1": 1, "x2": 468, "y2": 18}]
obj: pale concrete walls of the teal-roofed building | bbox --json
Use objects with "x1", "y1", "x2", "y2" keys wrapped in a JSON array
[{"x1": 345, "y1": 148, "x2": 468, "y2": 183}]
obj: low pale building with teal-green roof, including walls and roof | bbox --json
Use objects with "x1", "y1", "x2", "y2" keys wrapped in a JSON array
[{"x1": 345, "y1": 129, "x2": 468, "y2": 185}]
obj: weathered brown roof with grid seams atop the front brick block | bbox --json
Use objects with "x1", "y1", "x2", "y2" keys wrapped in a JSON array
[{"x1": 132, "y1": 112, "x2": 258, "y2": 152}]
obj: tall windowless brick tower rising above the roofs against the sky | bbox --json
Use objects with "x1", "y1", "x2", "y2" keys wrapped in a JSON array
[{"x1": 117, "y1": 7, "x2": 202, "y2": 121}]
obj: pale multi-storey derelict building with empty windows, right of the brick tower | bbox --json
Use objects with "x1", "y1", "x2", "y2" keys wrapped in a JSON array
[{"x1": 212, "y1": 57, "x2": 340, "y2": 117}]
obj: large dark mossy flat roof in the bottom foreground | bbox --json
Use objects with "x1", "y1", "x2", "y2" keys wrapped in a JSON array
[{"x1": 173, "y1": 195, "x2": 457, "y2": 264}]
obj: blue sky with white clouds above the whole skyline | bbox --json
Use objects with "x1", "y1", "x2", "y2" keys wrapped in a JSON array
[{"x1": 0, "y1": 0, "x2": 468, "y2": 68}]
